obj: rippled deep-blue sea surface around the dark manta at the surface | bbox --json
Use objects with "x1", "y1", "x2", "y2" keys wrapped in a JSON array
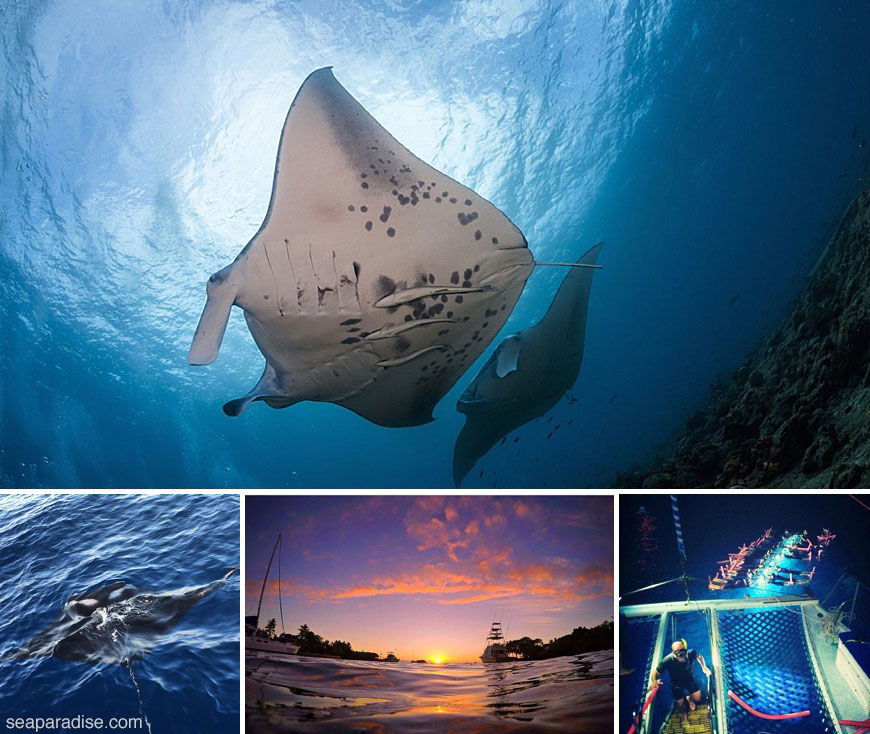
[{"x1": 0, "y1": 494, "x2": 240, "y2": 734}]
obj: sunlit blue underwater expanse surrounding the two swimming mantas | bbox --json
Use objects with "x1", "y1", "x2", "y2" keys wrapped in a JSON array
[{"x1": 0, "y1": 5, "x2": 870, "y2": 487}]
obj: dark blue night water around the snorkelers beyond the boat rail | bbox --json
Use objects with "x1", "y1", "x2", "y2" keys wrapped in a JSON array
[{"x1": 619, "y1": 494, "x2": 870, "y2": 608}]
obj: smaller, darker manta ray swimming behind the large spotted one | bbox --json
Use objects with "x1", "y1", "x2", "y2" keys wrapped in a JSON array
[{"x1": 453, "y1": 244, "x2": 603, "y2": 487}]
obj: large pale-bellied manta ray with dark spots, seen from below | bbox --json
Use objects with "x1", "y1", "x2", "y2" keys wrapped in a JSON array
[{"x1": 188, "y1": 68, "x2": 534, "y2": 427}]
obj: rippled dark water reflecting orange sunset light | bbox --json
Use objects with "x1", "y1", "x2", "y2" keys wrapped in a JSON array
[{"x1": 245, "y1": 651, "x2": 613, "y2": 734}]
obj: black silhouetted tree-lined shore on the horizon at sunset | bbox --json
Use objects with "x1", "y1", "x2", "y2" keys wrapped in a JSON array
[{"x1": 263, "y1": 619, "x2": 613, "y2": 662}]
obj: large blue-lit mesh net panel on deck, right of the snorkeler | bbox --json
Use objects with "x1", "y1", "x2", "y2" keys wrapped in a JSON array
[{"x1": 717, "y1": 608, "x2": 835, "y2": 734}]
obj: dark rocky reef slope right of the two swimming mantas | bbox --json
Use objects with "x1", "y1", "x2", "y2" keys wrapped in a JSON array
[{"x1": 616, "y1": 190, "x2": 870, "y2": 489}]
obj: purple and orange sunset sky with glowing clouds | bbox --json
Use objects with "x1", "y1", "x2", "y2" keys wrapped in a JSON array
[{"x1": 245, "y1": 496, "x2": 613, "y2": 662}]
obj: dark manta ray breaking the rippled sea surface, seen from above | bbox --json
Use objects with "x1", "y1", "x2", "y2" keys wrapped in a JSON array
[{"x1": 6, "y1": 568, "x2": 236, "y2": 665}]
